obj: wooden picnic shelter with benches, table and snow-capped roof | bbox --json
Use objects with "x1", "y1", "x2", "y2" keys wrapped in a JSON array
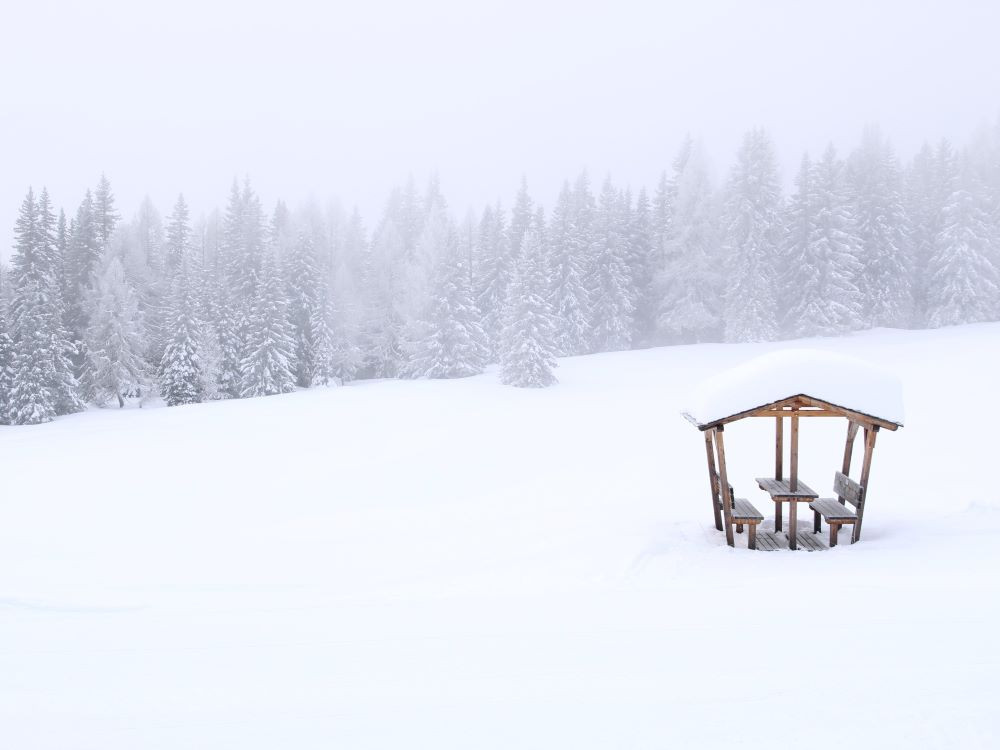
[{"x1": 682, "y1": 350, "x2": 903, "y2": 550}]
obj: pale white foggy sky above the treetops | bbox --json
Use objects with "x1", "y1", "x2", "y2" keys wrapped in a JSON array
[{"x1": 0, "y1": 0, "x2": 1000, "y2": 254}]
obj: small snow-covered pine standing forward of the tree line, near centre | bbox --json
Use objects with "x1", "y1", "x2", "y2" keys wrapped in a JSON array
[{"x1": 500, "y1": 227, "x2": 557, "y2": 388}]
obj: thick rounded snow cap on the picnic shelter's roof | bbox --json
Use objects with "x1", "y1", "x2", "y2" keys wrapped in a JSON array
[{"x1": 682, "y1": 349, "x2": 903, "y2": 427}]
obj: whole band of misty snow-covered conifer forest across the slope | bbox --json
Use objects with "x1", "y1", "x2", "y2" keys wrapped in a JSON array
[{"x1": 0, "y1": 124, "x2": 1000, "y2": 424}]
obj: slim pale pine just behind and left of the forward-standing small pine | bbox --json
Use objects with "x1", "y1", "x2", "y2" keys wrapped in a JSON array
[{"x1": 474, "y1": 202, "x2": 514, "y2": 361}]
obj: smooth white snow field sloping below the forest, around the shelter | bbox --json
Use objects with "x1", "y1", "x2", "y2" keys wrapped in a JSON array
[{"x1": 0, "y1": 325, "x2": 1000, "y2": 750}]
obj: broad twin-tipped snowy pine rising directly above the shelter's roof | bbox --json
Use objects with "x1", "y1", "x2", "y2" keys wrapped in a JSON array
[{"x1": 782, "y1": 146, "x2": 861, "y2": 337}]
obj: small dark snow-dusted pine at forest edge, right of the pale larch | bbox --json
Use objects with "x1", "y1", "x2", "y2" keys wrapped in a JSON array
[{"x1": 160, "y1": 261, "x2": 205, "y2": 406}]
